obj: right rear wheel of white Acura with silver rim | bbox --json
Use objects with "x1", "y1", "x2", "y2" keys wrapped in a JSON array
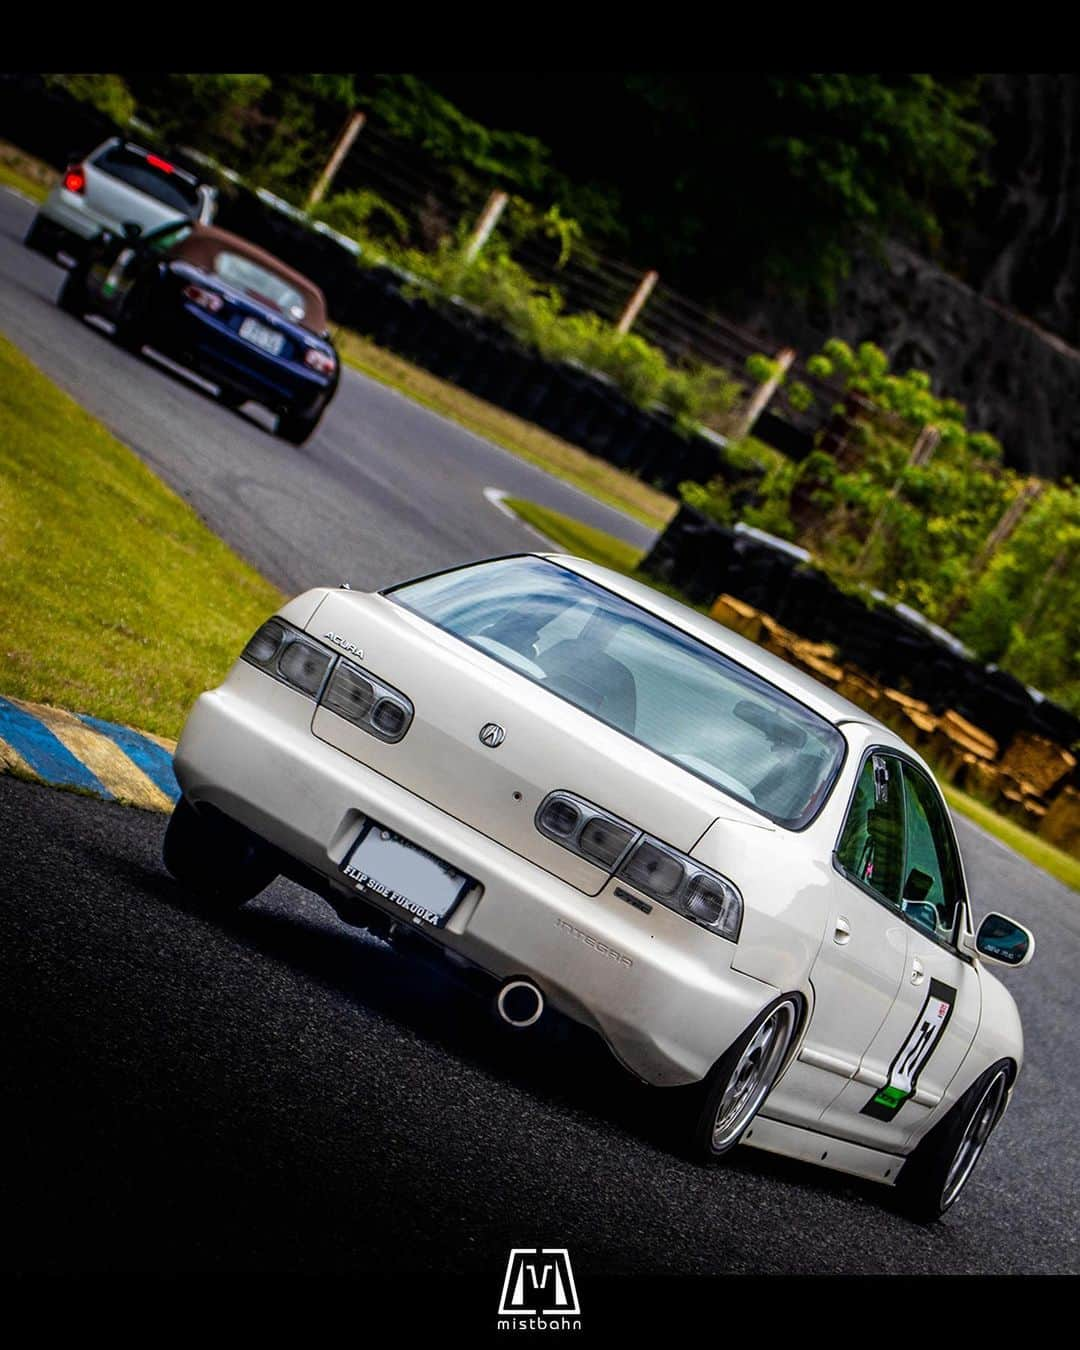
[{"x1": 689, "y1": 994, "x2": 803, "y2": 1164}]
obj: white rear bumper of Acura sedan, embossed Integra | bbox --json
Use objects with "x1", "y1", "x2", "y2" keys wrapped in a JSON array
[{"x1": 176, "y1": 663, "x2": 779, "y2": 1084}]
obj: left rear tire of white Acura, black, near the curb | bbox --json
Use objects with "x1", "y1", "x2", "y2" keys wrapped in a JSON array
[{"x1": 162, "y1": 797, "x2": 279, "y2": 910}]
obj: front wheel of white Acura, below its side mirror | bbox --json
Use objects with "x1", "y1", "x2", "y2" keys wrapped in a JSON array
[{"x1": 896, "y1": 1060, "x2": 1014, "y2": 1223}]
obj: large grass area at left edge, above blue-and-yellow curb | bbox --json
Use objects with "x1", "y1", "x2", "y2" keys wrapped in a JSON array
[{"x1": 0, "y1": 338, "x2": 281, "y2": 737}]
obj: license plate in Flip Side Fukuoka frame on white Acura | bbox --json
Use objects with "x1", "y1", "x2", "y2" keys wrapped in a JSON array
[{"x1": 342, "y1": 822, "x2": 473, "y2": 927}]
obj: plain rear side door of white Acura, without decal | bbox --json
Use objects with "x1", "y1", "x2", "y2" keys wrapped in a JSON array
[{"x1": 767, "y1": 749, "x2": 911, "y2": 1129}]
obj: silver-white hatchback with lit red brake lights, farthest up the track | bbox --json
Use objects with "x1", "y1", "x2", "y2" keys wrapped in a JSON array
[{"x1": 24, "y1": 136, "x2": 217, "y2": 259}]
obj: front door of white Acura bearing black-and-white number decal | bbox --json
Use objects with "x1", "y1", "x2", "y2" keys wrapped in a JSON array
[{"x1": 821, "y1": 757, "x2": 981, "y2": 1153}]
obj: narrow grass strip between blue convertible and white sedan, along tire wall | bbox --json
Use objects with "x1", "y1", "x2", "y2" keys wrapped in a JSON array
[{"x1": 335, "y1": 329, "x2": 679, "y2": 529}]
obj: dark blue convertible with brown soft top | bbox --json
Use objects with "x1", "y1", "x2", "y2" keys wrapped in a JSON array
[{"x1": 57, "y1": 220, "x2": 339, "y2": 446}]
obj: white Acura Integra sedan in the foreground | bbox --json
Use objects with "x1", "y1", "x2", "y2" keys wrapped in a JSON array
[{"x1": 165, "y1": 555, "x2": 1034, "y2": 1219}]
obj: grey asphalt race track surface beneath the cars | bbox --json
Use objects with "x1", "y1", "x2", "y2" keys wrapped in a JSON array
[{"x1": 0, "y1": 193, "x2": 1080, "y2": 1274}]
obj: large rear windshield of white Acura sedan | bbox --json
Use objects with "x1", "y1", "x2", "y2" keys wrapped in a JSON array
[{"x1": 387, "y1": 558, "x2": 845, "y2": 829}]
